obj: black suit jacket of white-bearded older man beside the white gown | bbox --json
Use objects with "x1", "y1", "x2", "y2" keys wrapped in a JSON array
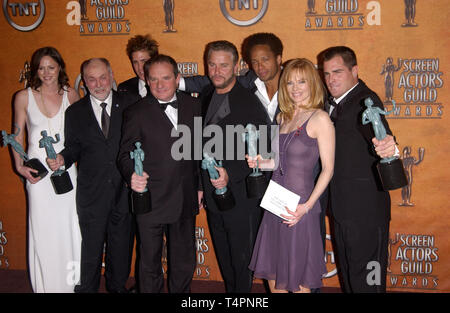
[{"x1": 61, "y1": 91, "x2": 129, "y2": 218}]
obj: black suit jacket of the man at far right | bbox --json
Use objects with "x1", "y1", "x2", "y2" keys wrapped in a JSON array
[{"x1": 330, "y1": 80, "x2": 392, "y2": 227}]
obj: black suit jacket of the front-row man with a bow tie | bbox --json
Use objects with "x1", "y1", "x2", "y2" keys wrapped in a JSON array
[{"x1": 118, "y1": 92, "x2": 201, "y2": 224}]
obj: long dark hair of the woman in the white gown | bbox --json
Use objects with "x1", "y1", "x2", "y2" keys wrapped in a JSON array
[{"x1": 27, "y1": 47, "x2": 69, "y2": 90}]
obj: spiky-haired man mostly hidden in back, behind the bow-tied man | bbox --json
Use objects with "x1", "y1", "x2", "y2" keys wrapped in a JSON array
[{"x1": 117, "y1": 34, "x2": 158, "y2": 104}]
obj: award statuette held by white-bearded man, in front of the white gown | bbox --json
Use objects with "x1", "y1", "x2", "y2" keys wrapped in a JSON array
[{"x1": 39, "y1": 130, "x2": 73, "y2": 195}]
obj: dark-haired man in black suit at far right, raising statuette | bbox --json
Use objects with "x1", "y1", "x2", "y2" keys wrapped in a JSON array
[{"x1": 319, "y1": 46, "x2": 396, "y2": 292}]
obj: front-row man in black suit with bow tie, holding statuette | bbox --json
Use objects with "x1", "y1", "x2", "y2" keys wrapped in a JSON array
[{"x1": 119, "y1": 54, "x2": 202, "y2": 293}]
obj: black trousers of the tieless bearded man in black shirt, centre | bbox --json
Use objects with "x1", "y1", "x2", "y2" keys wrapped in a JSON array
[{"x1": 207, "y1": 206, "x2": 261, "y2": 293}]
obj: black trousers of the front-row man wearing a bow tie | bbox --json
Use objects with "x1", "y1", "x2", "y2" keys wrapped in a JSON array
[{"x1": 137, "y1": 215, "x2": 196, "y2": 293}]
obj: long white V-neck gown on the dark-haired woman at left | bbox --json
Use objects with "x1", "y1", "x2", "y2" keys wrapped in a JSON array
[{"x1": 26, "y1": 88, "x2": 81, "y2": 293}]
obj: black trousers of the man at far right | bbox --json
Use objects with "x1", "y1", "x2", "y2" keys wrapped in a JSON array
[{"x1": 334, "y1": 221, "x2": 389, "y2": 293}]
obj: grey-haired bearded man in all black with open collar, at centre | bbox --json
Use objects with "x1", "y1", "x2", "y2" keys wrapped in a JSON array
[{"x1": 201, "y1": 41, "x2": 270, "y2": 293}]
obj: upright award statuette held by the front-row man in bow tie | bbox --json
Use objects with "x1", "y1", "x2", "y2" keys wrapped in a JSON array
[{"x1": 130, "y1": 141, "x2": 152, "y2": 214}]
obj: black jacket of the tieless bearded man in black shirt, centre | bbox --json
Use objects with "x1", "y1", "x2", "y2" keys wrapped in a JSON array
[{"x1": 201, "y1": 82, "x2": 270, "y2": 211}]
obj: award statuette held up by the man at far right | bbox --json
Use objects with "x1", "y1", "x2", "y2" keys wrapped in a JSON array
[{"x1": 362, "y1": 98, "x2": 408, "y2": 190}]
